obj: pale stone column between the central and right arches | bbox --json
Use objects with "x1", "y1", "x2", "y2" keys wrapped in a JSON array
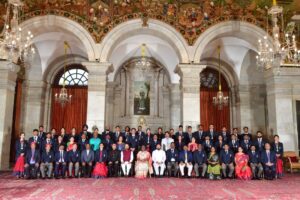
[{"x1": 175, "y1": 64, "x2": 206, "y2": 130}]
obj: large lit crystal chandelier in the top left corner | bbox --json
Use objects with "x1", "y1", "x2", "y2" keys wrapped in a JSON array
[{"x1": 0, "y1": 0, "x2": 35, "y2": 63}]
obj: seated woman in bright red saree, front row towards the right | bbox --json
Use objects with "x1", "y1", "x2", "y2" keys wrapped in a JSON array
[{"x1": 234, "y1": 147, "x2": 252, "y2": 180}]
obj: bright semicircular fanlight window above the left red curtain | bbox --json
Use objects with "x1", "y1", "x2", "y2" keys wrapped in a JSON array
[{"x1": 58, "y1": 69, "x2": 88, "y2": 86}]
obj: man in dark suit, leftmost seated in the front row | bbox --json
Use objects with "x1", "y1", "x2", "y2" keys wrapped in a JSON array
[{"x1": 24, "y1": 142, "x2": 41, "y2": 179}]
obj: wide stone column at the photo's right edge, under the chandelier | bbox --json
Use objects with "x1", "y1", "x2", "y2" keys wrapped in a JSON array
[{"x1": 264, "y1": 67, "x2": 300, "y2": 151}]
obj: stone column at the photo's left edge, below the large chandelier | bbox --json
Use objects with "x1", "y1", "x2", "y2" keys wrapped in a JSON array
[{"x1": 0, "y1": 61, "x2": 19, "y2": 170}]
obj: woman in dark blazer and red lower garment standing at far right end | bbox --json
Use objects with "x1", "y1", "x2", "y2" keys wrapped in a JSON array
[{"x1": 272, "y1": 135, "x2": 283, "y2": 178}]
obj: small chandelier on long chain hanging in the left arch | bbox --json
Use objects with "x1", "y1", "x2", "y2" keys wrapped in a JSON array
[{"x1": 55, "y1": 41, "x2": 72, "y2": 107}]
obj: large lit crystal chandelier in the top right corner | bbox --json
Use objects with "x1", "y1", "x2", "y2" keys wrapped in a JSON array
[{"x1": 256, "y1": 0, "x2": 300, "y2": 72}]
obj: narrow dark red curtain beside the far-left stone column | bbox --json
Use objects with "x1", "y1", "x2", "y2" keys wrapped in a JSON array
[{"x1": 10, "y1": 79, "x2": 23, "y2": 162}]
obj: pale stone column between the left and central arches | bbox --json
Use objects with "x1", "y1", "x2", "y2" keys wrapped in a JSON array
[{"x1": 82, "y1": 62, "x2": 113, "y2": 131}]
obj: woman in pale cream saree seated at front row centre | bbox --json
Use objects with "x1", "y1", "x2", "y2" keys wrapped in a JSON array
[{"x1": 135, "y1": 145, "x2": 153, "y2": 179}]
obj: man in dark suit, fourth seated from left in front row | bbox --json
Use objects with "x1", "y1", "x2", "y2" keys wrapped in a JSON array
[{"x1": 67, "y1": 143, "x2": 80, "y2": 178}]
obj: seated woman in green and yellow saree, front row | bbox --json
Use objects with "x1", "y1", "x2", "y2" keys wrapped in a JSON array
[{"x1": 207, "y1": 147, "x2": 221, "y2": 180}]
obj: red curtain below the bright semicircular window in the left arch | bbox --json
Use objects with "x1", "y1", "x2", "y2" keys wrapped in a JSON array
[{"x1": 51, "y1": 86, "x2": 87, "y2": 133}]
